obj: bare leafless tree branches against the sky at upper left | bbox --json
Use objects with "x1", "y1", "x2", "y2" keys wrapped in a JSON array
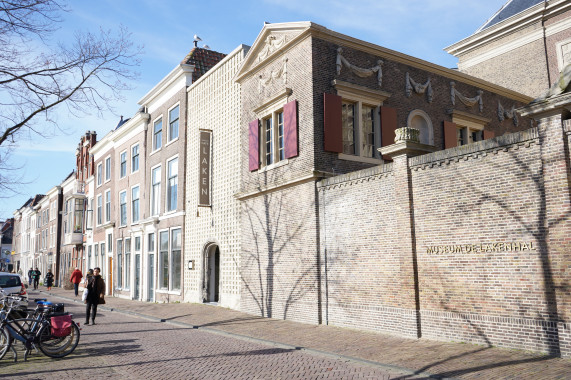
[{"x1": 0, "y1": 0, "x2": 141, "y2": 145}]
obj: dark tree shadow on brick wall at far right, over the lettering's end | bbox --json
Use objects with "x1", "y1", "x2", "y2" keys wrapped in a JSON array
[{"x1": 450, "y1": 126, "x2": 571, "y2": 356}]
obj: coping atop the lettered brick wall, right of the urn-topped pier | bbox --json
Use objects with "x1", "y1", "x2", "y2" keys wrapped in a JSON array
[{"x1": 409, "y1": 127, "x2": 538, "y2": 170}]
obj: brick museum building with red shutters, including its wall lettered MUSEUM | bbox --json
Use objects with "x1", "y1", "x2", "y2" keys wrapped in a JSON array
[{"x1": 231, "y1": 23, "x2": 571, "y2": 355}]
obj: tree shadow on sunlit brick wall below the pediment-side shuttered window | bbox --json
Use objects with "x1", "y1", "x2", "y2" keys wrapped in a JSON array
[{"x1": 240, "y1": 191, "x2": 320, "y2": 319}]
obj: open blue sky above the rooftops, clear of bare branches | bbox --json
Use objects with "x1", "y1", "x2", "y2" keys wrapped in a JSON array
[{"x1": 0, "y1": 0, "x2": 505, "y2": 221}]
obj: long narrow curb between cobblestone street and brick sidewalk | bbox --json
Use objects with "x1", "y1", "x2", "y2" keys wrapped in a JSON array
[{"x1": 40, "y1": 290, "x2": 457, "y2": 380}]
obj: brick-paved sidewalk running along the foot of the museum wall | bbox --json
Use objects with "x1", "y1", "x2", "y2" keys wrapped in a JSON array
[{"x1": 39, "y1": 288, "x2": 571, "y2": 379}]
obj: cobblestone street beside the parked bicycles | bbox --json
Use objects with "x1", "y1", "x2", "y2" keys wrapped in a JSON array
[{"x1": 0, "y1": 294, "x2": 408, "y2": 379}]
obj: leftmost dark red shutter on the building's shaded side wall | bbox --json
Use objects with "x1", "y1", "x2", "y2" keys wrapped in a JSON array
[{"x1": 323, "y1": 93, "x2": 343, "y2": 153}]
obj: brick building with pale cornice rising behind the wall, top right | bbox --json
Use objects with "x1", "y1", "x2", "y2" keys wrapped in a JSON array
[{"x1": 445, "y1": 0, "x2": 571, "y2": 98}]
